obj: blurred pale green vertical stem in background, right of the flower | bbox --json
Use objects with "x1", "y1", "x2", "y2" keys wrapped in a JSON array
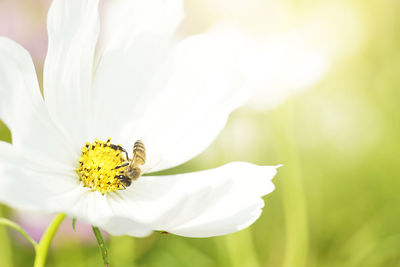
[{"x1": 276, "y1": 100, "x2": 309, "y2": 267}]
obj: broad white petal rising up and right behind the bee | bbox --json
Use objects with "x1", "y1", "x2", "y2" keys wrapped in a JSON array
[{"x1": 95, "y1": 35, "x2": 247, "y2": 171}]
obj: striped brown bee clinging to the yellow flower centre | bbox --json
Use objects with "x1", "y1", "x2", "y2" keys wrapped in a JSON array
[{"x1": 111, "y1": 140, "x2": 146, "y2": 187}]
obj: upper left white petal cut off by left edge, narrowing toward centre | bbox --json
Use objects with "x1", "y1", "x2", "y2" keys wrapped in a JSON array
[{"x1": 0, "y1": 37, "x2": 74, "y2": 169}]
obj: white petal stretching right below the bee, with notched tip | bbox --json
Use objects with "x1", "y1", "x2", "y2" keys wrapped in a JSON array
[{"x1": 109, "y1": 162, "x2": 276, "y2": 237}]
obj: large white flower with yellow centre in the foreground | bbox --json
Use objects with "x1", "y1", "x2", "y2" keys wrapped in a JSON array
[{"x1": 0, "y1": 0, "x2": 276, "y2": 237}]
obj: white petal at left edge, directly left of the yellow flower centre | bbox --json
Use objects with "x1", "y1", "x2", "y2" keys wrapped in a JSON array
[{"x1": 0, "y1": 142, "x2": 77, "y2": 212}]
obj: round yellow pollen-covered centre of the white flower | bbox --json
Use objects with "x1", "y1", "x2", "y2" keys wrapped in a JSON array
[{"x1": 77, "y1": 138, "x2": 127, "y2": 195}]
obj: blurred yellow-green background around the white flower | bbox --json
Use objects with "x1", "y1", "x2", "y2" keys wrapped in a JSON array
[{"x1": 0, "y1": 0, "x2": 400, "y2": 267}]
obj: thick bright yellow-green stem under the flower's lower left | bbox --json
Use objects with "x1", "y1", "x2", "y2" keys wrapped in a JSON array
[{"x1": 33, "y1": 213, "x2": 65, "y2": 267}]
